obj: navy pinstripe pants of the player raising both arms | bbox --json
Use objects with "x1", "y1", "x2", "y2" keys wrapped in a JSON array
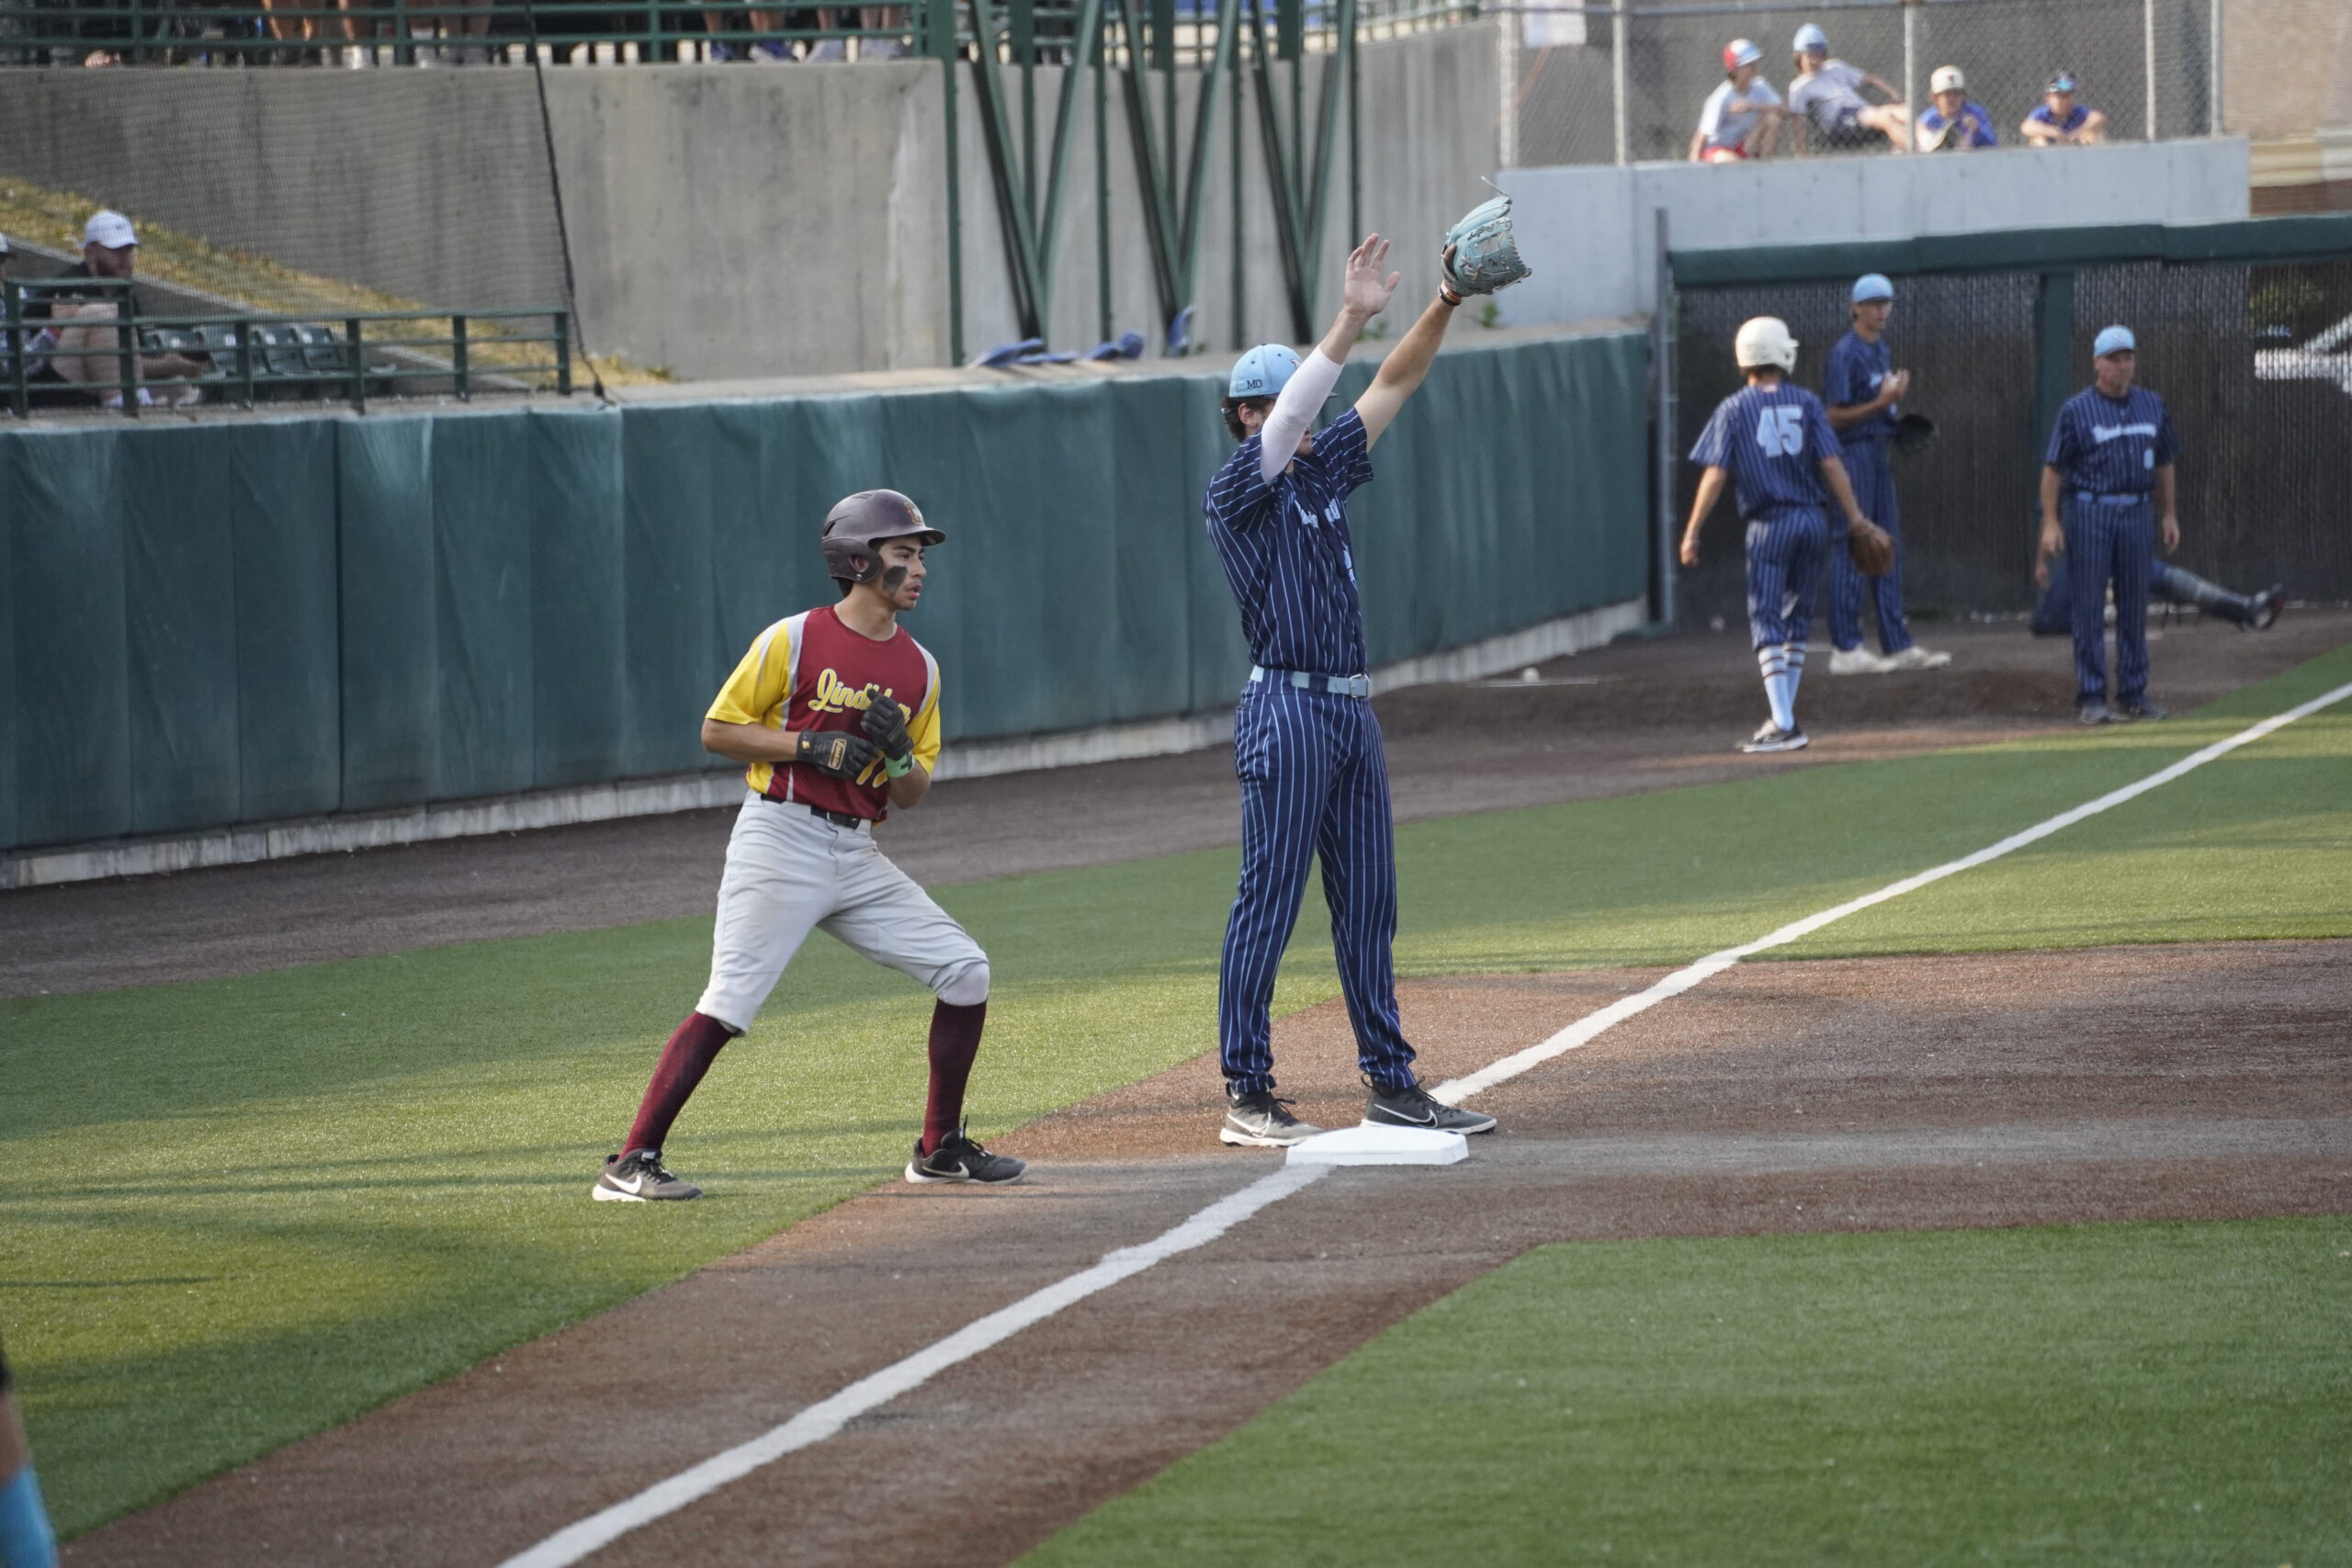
[{"x1": 1216, "y1": 682, "x2": 1414, "y2": 1093}]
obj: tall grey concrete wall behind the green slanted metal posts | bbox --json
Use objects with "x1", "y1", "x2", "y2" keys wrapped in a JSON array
[{"x1": 0, "y1": 26, "x2": 1496, "y2": 378}]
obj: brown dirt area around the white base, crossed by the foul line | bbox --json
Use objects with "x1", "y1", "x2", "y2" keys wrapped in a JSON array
[{"x1": 66, "y1": 942, "x2": 2352, "y2": 1565}]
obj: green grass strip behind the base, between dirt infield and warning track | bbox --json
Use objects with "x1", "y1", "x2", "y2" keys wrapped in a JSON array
[{"x1": 0, "y1": 649, "x2": 2352, "y2": 1533}]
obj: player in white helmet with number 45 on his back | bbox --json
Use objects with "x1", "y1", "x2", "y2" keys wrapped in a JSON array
[{"x1": 1681, "y1": 315, "x2": 1870, "y2": 752}]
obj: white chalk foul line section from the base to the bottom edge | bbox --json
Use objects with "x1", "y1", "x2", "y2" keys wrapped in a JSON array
[{"x1": 499, "y1": 1166, "x2": 1331, "y2": 1568}]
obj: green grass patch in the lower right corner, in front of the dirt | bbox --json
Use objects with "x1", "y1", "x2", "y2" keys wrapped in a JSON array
[{"x1": 1023, "y1": 1218, "x2": 2352, "y2": 1568}]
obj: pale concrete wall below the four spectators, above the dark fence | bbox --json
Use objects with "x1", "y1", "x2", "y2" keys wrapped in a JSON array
[{"x1": 1500, "y1": 139, "x2": 2246, "y2": 324}]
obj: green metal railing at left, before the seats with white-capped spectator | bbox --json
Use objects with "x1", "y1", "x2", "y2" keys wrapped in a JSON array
[{"x1": 0, "y1": 277, "x2": 571, "y2": 419}]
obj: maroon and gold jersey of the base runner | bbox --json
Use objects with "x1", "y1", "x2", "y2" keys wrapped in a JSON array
[{"x1": 710, "y1": 604, "x2": 938, "y2": 823}]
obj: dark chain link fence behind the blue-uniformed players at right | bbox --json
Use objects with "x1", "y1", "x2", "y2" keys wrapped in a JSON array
[{"x1": 1672, "y1": 259, "x2": 2352, "y2": 635}]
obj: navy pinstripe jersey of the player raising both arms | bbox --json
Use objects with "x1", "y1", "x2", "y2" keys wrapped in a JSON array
[{"x1": 1202, "y1": 409, "x2": 1371, "y2": 674}]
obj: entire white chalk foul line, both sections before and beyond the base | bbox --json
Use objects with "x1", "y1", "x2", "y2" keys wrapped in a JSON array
[{"x1": 499, "y1": 684, "x2": 2352, "y2": 1568}]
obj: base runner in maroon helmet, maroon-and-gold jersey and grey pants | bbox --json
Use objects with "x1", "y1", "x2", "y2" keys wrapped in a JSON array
[{"x1": 595, "y1": 489, "x2": 1023, "y2": 1201}]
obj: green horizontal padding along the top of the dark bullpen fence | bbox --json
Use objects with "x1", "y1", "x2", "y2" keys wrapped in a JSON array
[{"x1": 1672, "y1": 211, "x2": 2352, "y2": 287}]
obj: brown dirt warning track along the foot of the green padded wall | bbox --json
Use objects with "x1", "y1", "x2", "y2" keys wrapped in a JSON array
[{"x1": 0, "y1": 611, "x2": 2352, "y2": 997}]
